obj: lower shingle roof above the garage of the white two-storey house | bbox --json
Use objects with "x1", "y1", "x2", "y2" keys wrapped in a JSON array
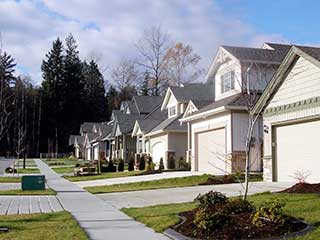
[{"x1": 191, "y1": 93, "x2": 260, "y2": 116}]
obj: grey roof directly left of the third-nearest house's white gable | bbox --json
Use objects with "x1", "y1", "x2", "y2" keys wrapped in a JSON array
[{"x1": 132, "y1": 96, "x2": 163, "y2": 114}]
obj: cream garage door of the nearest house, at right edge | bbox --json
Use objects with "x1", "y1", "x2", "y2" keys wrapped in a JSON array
[{"x1": 275, "y1": 121, "x2": 320, "y2": 182}]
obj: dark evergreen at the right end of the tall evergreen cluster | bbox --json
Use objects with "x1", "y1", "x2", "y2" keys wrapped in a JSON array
[{"x1": 83, "y1": 60, "x2": 107, "y2": 121}]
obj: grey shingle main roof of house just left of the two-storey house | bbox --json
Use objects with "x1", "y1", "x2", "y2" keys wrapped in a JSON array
[{"x1": 170, "y1": 83, "x2": 214, "y2": 102}]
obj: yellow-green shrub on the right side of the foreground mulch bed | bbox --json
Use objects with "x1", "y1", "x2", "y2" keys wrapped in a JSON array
[{"x1": 252, "y1": 199, "x2": 286, "y2": 227}]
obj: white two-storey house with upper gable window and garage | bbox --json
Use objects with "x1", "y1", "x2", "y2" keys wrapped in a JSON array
[{"x1": 181, "y1": 43, "x2": 290, "y2": 174}]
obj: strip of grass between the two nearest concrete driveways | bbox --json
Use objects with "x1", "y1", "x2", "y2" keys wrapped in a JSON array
[{"x1": 85, "y1": 174, "x2": 261, "y2": 194}]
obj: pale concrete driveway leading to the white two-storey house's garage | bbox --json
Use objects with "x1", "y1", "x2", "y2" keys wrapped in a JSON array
[{"x1": 75, "y1": 171, "x2": 203, "y2": 188}]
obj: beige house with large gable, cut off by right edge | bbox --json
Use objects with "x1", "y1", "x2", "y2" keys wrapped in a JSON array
[{"x1": 254, "y1": 46, "x2": 320, "y2": 182}]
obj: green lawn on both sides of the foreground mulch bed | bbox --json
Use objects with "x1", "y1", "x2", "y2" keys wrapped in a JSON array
[{"x1": 122, "y1": 193, "x2": 320, "y2": 240}]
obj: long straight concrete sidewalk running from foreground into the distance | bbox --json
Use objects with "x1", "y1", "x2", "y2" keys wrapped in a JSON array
[{"x1": 35, "y1": 160, "x2": 168, "y2": 240}]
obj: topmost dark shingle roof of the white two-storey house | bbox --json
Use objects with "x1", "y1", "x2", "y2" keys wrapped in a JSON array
[{"x1": 221, "y1": 44, "x2": 290, "y2": 64}]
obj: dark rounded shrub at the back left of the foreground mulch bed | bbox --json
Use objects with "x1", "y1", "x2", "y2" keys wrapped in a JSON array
[{"x1": 195, "y1": 191, "x2": 228, "y2": 208}]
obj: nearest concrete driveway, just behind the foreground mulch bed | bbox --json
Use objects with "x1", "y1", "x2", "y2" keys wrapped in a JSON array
[{"x1": 97, "y1": 182, "x2": 292, "y2": 209}]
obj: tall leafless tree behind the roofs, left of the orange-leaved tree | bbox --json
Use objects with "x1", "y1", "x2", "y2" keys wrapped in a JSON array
[{"x1": 136, "y1": 26, "x2": 170, "y2": 96}]
